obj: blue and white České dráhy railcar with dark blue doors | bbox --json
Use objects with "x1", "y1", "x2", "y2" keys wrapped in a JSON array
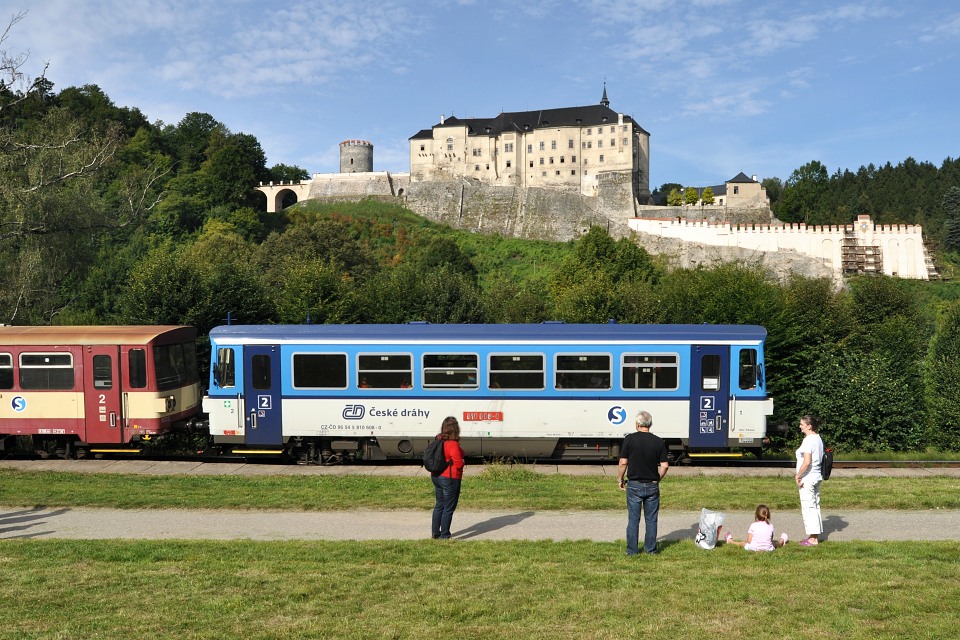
[{"x1": 203, "y1": 323, "x2": 773, "y2": 462}]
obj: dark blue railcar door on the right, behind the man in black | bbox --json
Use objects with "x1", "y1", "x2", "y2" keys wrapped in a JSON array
[{"x1": 690, "y1": 345, "x2": 730, "y2": 449}]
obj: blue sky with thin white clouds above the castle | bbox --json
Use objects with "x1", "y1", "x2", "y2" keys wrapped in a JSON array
[{"x1": 7, "y1": 0, "x2": 960, "y2": 189}]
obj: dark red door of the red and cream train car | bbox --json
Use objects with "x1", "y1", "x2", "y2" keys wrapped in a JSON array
[{"x1": 83, "y1": 345, "x2": 125, "y2": 444}]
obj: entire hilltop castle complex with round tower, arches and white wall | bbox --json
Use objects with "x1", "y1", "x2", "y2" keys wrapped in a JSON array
[{"x1": 256, "y1": 84, "x2": 936, "y2": 282}]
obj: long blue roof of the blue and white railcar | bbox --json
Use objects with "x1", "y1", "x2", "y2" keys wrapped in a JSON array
[{"x1": 210, "y1": 322, "x2": 767, "y2": 344}]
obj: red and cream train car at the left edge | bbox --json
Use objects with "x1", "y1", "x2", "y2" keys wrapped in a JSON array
[{"x1": 0, "y1": 326, "x2": 201, "y2": 455}]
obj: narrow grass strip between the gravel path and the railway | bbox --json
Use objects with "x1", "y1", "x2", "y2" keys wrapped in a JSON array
[{"x1": 0, "y1": 465, "x2": 960, "y2": 511}]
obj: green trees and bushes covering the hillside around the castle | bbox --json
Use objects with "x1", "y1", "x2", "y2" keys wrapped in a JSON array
[{"x1": 0, "y1": 25, "x2": 960, "y2": 451}]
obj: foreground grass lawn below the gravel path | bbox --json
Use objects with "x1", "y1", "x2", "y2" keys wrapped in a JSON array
[{"x1": 0, "y1": 540, "x2": 960, "y2": 640}]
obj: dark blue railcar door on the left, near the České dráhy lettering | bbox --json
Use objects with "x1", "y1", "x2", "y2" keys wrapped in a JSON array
[{"x1": 243, "y1": 345, "x2": 283, "y2": 445}]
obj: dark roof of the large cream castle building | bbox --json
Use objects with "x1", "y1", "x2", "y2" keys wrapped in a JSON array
[{"x1": 410, "y1": 104, "x2": 650, "y2": 140}]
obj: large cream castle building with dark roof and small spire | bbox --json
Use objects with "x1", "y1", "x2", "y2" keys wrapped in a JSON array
[{"x1": 410, "y1": 84, "x2": 650, "y2": 202}]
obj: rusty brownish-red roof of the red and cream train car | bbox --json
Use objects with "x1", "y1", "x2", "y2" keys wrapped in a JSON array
[{"x1": 0, "y1": 325, "x2": 197, "y2": 346}]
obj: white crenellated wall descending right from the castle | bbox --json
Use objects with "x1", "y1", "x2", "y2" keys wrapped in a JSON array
[{"x1": 628, "y1": 216, "x2": 930, "y2": 280}]
